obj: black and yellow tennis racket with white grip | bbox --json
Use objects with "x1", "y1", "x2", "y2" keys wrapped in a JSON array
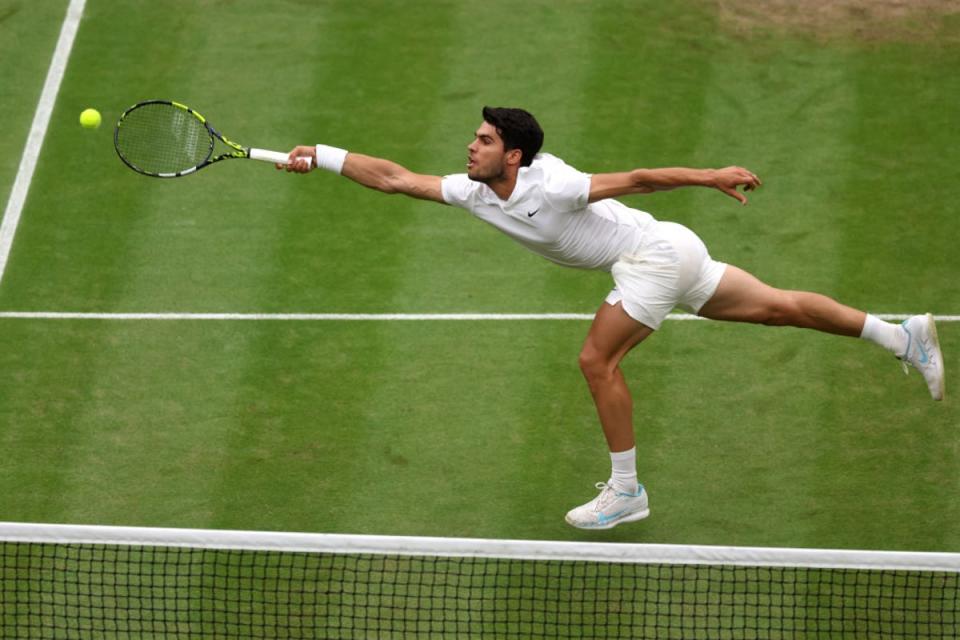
[{"x1": 113, "y1": 100, "x2": 310, "y2": 178}]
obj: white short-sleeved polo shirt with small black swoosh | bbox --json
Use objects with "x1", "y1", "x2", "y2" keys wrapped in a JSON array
[{"x1": 442, "y1": 153, "x2": 656, "y2": 271}]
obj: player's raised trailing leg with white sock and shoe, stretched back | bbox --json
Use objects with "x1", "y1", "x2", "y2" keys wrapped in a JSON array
[{"x1": 698, "y1": 265, "x2": 944, "y2": 400}]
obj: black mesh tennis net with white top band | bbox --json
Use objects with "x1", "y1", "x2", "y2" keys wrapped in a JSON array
[{"x1": 0, "y1": 523, "x2": 960, "y2": 640}]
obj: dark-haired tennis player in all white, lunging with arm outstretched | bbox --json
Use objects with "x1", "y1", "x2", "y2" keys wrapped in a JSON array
[{"x1": 278, "y1": 107, "x2": 944, "y2": 529}]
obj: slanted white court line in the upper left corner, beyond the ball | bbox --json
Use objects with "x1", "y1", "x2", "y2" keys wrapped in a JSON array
[{"x1": 0, "y1": 0, "x2": 86, "y2": 281}]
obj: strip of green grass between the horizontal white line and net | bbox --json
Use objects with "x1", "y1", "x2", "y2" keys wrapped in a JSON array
[{"x1": 0, "y1": 322, "x2": 960, "y2": 549}]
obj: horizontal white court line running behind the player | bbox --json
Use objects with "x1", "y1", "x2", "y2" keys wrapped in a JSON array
[{"x1": 0, "y1": 311, "x2": 960, "y2": 322}]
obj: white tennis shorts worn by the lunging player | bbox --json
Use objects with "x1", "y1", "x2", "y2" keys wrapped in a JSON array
[{"x1": 606, "y1": 221, "x2": 727, "y2": 329}]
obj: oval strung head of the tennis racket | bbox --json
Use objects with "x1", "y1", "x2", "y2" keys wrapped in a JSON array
[{"x1": 115, "y1": 102, "x2": 214, "y2": 175}]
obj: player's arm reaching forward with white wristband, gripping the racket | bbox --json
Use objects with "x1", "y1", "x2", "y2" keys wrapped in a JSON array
[{"x1": 278, "y1": 145, "x2": 444, "y2": 202}]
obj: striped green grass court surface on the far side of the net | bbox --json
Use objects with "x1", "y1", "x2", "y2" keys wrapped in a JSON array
[{"x1": 0, "y1": 0, "x2": 960, "y2": 551}]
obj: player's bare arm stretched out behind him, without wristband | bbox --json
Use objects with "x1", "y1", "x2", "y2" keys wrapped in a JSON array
[{"x1": 590, "y1": 167, "x2": 761, "y2": 204}]
